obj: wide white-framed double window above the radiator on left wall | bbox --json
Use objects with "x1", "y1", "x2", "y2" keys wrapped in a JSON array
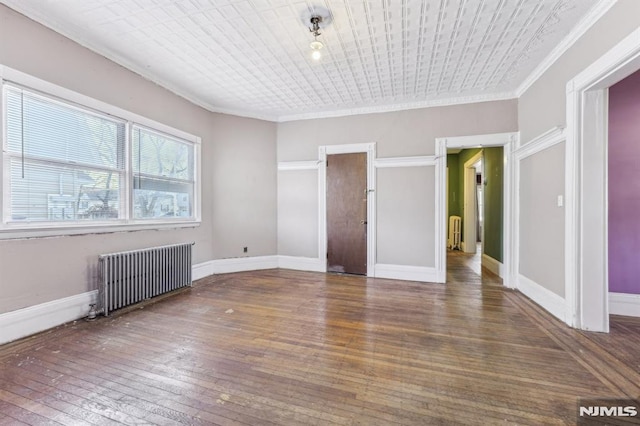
[{"x1": 0, "y1": 75, "x2": 199, "y2": 238}]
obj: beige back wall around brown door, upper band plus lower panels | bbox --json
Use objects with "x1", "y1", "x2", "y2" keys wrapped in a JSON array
[{"x1": 277, "y1": 100, "x2": 518, "y2": 267}]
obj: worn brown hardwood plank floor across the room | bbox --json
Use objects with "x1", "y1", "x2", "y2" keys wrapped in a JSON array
[{"x1": 0, "y1": 252, "x2": 640, "y2": 425}]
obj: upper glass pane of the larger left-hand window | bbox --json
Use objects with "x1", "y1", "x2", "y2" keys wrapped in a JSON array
[{"x1": 6, "y1": 87, "x2": 125, "y2": 169}]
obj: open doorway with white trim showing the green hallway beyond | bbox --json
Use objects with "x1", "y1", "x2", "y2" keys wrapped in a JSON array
[{"x1": 436, "y1": 133, "x2": 518, "y2": 287}]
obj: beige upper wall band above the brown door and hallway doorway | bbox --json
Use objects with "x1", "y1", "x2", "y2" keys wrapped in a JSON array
[{"x1": 278, "y1": 100, "x2": 518, "y2": 161}]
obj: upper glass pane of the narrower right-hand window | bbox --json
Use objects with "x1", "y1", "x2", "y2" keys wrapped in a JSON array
[{"x1": 133, "y1": 127, "x2": 193, "y2": 181}]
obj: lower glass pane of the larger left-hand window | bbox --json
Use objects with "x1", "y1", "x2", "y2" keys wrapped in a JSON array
[{"x1": 10, "y1": 159, "x2": 120, "y2": 221}]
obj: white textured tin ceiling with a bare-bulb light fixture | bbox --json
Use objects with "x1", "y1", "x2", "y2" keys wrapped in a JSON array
[{"x1": 0, "y1": 0, "x2": 602, "y2": 120}]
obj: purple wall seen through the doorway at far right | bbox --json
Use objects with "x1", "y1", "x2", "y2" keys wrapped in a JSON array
[{"x1": 609, "y1": 71, "x2": 640, "y2": 294}]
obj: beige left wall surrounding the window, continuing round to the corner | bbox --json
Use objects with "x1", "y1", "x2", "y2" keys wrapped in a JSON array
[{"x1": 0, "y1": 5, "x2": 277, "y2": 313}]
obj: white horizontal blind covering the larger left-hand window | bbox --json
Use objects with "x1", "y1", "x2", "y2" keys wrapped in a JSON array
[{"x1": 4, "y1": 85, "x2": 126, "y2": 222}]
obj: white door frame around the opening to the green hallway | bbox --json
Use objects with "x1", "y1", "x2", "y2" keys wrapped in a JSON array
[{"x1": 435, "y1": 132, "x2": 519, "y2": 288}]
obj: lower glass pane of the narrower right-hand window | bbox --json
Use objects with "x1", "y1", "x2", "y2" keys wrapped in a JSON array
[{"x1": 133, "y1": 178, "x2": 193, "y2": 219}]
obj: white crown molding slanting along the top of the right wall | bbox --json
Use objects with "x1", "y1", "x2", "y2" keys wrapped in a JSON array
[{"x1": 515, "y1": 0, "x2": 618, "y2": 98}]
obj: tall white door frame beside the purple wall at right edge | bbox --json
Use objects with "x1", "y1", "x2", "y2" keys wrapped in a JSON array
[{"x1": 565, "y1": 29, "x2": 640, "y2": 332}]
